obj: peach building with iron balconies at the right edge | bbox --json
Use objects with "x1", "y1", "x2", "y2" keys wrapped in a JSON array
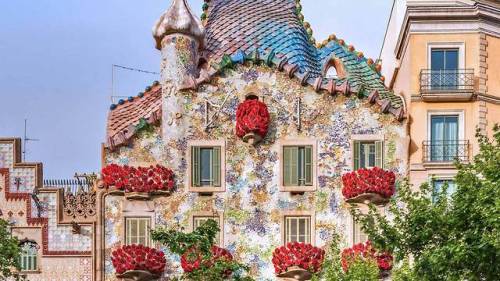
[{"x1": 381, "y1": 0, "x2": 500, "y2": 192}]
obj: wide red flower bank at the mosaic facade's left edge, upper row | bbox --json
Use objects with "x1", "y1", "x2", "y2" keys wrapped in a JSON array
[{"x1": 102, "y1": 164, "x2": 174, "y2": 193}]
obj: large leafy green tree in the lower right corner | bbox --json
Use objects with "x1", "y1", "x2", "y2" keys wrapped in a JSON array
[{"x1": 355, "y1": 126, "x2": 500, "y2": 281}]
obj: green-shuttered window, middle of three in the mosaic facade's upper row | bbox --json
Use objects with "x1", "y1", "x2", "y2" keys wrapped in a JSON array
[{"x1": 283, "y1": 145, "x2": 313, "y2": 186}]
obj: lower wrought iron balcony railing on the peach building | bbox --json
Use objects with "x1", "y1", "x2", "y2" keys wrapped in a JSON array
[{"x1": 422, "y1": 140, "x2": 469, "y2": 163}]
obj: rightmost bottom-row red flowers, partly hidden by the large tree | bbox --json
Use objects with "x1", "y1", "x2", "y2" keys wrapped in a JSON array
[{"x1": 341, "y1": 241, "x2": 393, "y2": 272}]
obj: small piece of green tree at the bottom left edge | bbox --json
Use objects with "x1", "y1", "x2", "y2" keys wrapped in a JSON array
[{"x1": 0, "y1": 219, "x2": 21, "y2": 280}]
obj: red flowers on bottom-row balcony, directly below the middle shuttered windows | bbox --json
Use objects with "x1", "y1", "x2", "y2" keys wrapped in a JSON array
[{"x1": 272, "y1": 242, "x2": 325, "y2": 274}]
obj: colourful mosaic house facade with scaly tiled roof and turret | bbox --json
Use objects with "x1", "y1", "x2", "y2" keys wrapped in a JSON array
[{"x1": 98, "y1": 0, "x2": 407, "y2": 280}]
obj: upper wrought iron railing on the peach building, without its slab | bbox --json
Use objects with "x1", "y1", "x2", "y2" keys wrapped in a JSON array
[{"x1": 420, "y1": 69, "x2": 474, "y2": 93}]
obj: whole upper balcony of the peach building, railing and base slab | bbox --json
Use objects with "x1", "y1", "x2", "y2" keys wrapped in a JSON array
[{"x1": 420, "y1": 69, "x2": 474, "y2": 102}]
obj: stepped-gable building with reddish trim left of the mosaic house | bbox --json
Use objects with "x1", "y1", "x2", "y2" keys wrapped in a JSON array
[{"x1": 0, "y1": 139, "x2": 96, "y2": 281}]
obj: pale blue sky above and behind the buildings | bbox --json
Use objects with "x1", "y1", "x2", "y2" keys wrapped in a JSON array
[{"x1": 0, "y1": 0, "x2": 392, "y2": 179}]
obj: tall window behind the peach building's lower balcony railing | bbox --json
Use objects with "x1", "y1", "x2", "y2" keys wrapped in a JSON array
[{"x1": 430, "y1": 115, "x2": 459, "y2": 162}]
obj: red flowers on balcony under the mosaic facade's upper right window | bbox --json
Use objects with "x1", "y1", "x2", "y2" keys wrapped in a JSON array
[{"x1": 342, "y1": 167, "x2": 396, "y2": 199}]
